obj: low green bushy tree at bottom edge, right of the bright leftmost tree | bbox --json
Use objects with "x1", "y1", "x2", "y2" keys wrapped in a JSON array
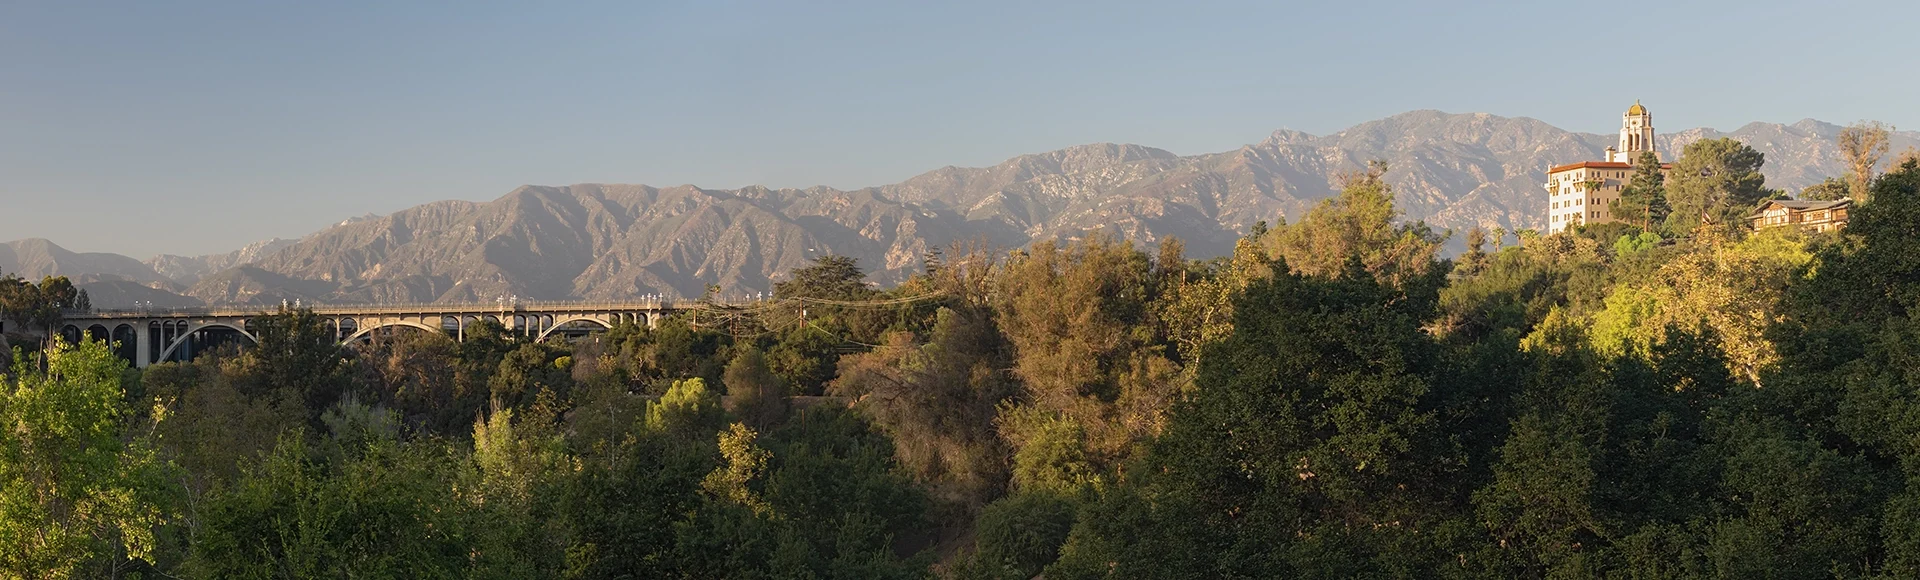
[{"x1": 186, "y1": 430, "x2": 493, "y2": 578}]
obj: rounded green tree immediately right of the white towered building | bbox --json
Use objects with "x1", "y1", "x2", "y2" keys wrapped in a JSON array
[{"x1": 1667, "y1": 138, "x2": 1774, "y2": 232}]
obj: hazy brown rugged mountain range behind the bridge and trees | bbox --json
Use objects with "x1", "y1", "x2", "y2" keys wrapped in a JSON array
[{"x1": 0, "y1": 111, "x2": 1920, "y2": 307}]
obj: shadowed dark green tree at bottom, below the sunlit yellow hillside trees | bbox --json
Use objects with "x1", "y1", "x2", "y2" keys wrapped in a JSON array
[{"x1": 1473, "y1": 313, "x2": 1734, "y2": 578}]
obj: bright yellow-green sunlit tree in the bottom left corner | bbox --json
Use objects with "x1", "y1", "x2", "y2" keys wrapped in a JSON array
[{"x1": 0, "y1": 338, "x2": 179, "y2": 578}]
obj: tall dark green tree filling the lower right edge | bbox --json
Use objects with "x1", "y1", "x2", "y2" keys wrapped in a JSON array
[{"x1": 1758, "y1": 161, "x2": 1920, "y2": 576}]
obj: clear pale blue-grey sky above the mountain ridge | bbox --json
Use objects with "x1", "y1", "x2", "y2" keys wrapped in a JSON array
[{"x1": 0, "y1": 0, "x2": 1920, "y2": 259}]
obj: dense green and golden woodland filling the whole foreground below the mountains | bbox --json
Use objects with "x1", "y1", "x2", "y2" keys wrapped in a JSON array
[{"x1": 11, "y1": 156, "x2": 1920, "y2": 578}]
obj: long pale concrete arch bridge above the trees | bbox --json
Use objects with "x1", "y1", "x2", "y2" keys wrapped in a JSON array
[{"x1": 60, "y1": 300, "x2": 714, "y2": 369}]
